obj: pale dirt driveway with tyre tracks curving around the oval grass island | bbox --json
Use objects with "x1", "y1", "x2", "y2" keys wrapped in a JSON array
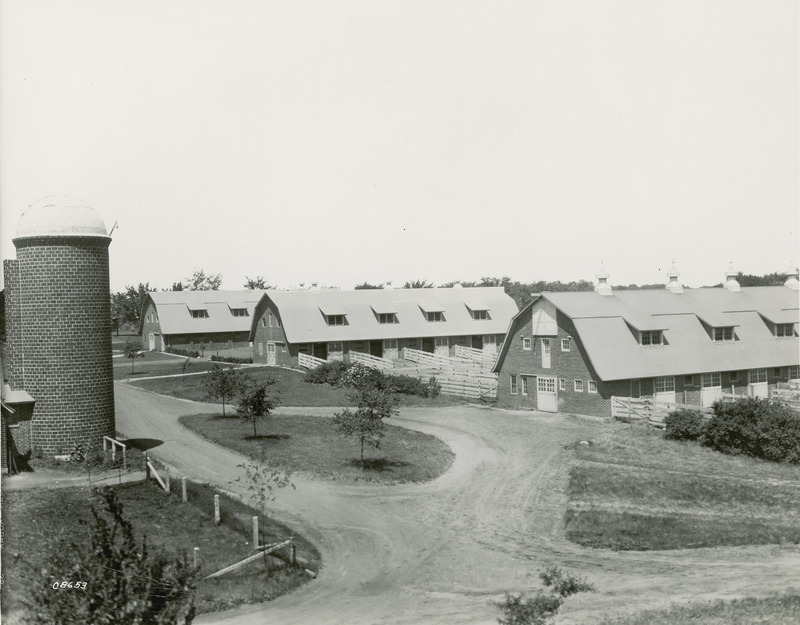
[{"x1": 115, "y1": 383, "x2": 800, "y2": 625}]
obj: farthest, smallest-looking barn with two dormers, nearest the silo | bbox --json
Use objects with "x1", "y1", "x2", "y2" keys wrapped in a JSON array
[{"x1": 139, "y1": 290, "x2": 264, "y2": 351}]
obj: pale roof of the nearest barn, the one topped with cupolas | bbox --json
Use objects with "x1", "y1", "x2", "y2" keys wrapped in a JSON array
[{"x1": 495, "y1": 286, "x2": 800, "y2": 380}]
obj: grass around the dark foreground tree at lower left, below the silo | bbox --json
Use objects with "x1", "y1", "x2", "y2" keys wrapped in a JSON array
[{"x1": 2, "y1": 482, "x2": 319, "y2": 618}]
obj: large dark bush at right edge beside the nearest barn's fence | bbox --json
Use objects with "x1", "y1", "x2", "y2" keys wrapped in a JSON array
[{"x1": 703, "y1": 397, "x2": 800, "y2": 464}]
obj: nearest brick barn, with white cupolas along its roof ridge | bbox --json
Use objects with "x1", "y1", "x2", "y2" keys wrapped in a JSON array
[{"x1": 494, "y1": 268, "x2": 800, "y2": 417}]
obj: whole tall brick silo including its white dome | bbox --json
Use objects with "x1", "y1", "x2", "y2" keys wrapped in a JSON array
[{"x1": 3, "y1": 197, "x2": 115, "y2": 460}]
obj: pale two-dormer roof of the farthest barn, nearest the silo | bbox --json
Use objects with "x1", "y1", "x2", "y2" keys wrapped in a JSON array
[{"x1": 139, "y1": 289, "x2": 264, "y2": 335}]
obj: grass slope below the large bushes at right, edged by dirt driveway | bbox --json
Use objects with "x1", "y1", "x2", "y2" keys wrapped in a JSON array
[{"x1": 566, "y1": 424, "x2": 800, "y2": 550}]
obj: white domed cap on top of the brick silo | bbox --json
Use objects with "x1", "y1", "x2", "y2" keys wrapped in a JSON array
[{"x1": 17, "y1": 196, "x2": 108, "y2": 238}]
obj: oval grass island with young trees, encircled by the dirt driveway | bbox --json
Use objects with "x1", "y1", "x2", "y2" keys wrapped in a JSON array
[{"x1": 181, "y1": 415, "x2": 454, "y2": 483}]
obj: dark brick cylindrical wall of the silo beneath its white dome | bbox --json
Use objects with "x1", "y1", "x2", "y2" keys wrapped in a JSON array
[{"x1": 11, "y1": 236, "x2": 115, "y2": 455}]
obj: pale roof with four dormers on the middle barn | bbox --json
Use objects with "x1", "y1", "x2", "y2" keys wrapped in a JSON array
[{"x1": 250, "y1": 287, "x2": 517, "y2": 343}]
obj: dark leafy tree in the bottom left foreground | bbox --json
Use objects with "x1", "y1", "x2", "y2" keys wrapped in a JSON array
[{"x1": 28, "y1": 487, "x2": 198, "y2": 625}]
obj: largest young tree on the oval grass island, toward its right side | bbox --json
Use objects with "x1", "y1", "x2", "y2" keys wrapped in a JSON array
[{"x1": 333, "y1": 365, "x2": 397, "y2": 466}]
